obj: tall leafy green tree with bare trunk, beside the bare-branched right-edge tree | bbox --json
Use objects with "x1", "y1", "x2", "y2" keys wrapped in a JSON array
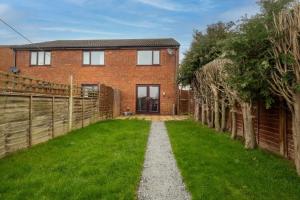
[{"x1": 220, "y1": 0, "x2": 291, "y2": 148}]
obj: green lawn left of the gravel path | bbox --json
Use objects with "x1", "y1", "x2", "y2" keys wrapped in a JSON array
[{"x1": 0, "y1": 120, "x2": 150, "y2": 200}]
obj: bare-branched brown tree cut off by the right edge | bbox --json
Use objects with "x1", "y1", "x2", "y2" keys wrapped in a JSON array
[{"x1": 265, "y1": 3, "x2": 300, "y2": 175}]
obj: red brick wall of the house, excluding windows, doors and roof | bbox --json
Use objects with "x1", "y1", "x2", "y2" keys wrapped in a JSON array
[{"x1": 17, "y1": 49, "x2": 179, "y2": 114}]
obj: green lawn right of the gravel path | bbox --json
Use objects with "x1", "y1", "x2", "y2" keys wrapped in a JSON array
[{"x1": 167, "y1": 121, "x2": 300, "y2": 200}]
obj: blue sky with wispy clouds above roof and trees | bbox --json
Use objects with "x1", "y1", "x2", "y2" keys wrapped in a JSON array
[{"x1": 0, "y1": 0, "x2": 259, "y2": 58}]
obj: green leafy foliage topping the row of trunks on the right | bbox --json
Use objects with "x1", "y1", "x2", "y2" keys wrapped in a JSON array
[{"x1": 178, "y1": 0, "x2": 296, "y2": 107}]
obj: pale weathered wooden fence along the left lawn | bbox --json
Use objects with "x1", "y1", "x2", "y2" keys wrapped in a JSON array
[{"x1": 0, "y1": 72, "x2": 118, "y2": 157}]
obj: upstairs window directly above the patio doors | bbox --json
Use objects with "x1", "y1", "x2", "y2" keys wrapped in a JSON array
[{"x1": 137, "y1": 50, "x2": 160, "y2": 65}]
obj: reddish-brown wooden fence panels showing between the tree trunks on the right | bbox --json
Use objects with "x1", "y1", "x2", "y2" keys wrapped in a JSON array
[{"x1": 195, "y1": 100, "x2": 294, "y2": 160}]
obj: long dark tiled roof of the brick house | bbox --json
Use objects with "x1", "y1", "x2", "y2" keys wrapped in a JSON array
[{"x1": 12, "y1": 38, "x2": 180, "y2": 49}]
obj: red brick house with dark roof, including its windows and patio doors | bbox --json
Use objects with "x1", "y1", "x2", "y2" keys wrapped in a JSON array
[{"x1": 6, "y1": 38, "x2": 180, "y2": 115}]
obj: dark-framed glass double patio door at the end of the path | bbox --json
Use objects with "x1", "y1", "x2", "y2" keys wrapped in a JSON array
[{"x1": 136, "y1": 85, "x2": 160, "y2": 114}]
